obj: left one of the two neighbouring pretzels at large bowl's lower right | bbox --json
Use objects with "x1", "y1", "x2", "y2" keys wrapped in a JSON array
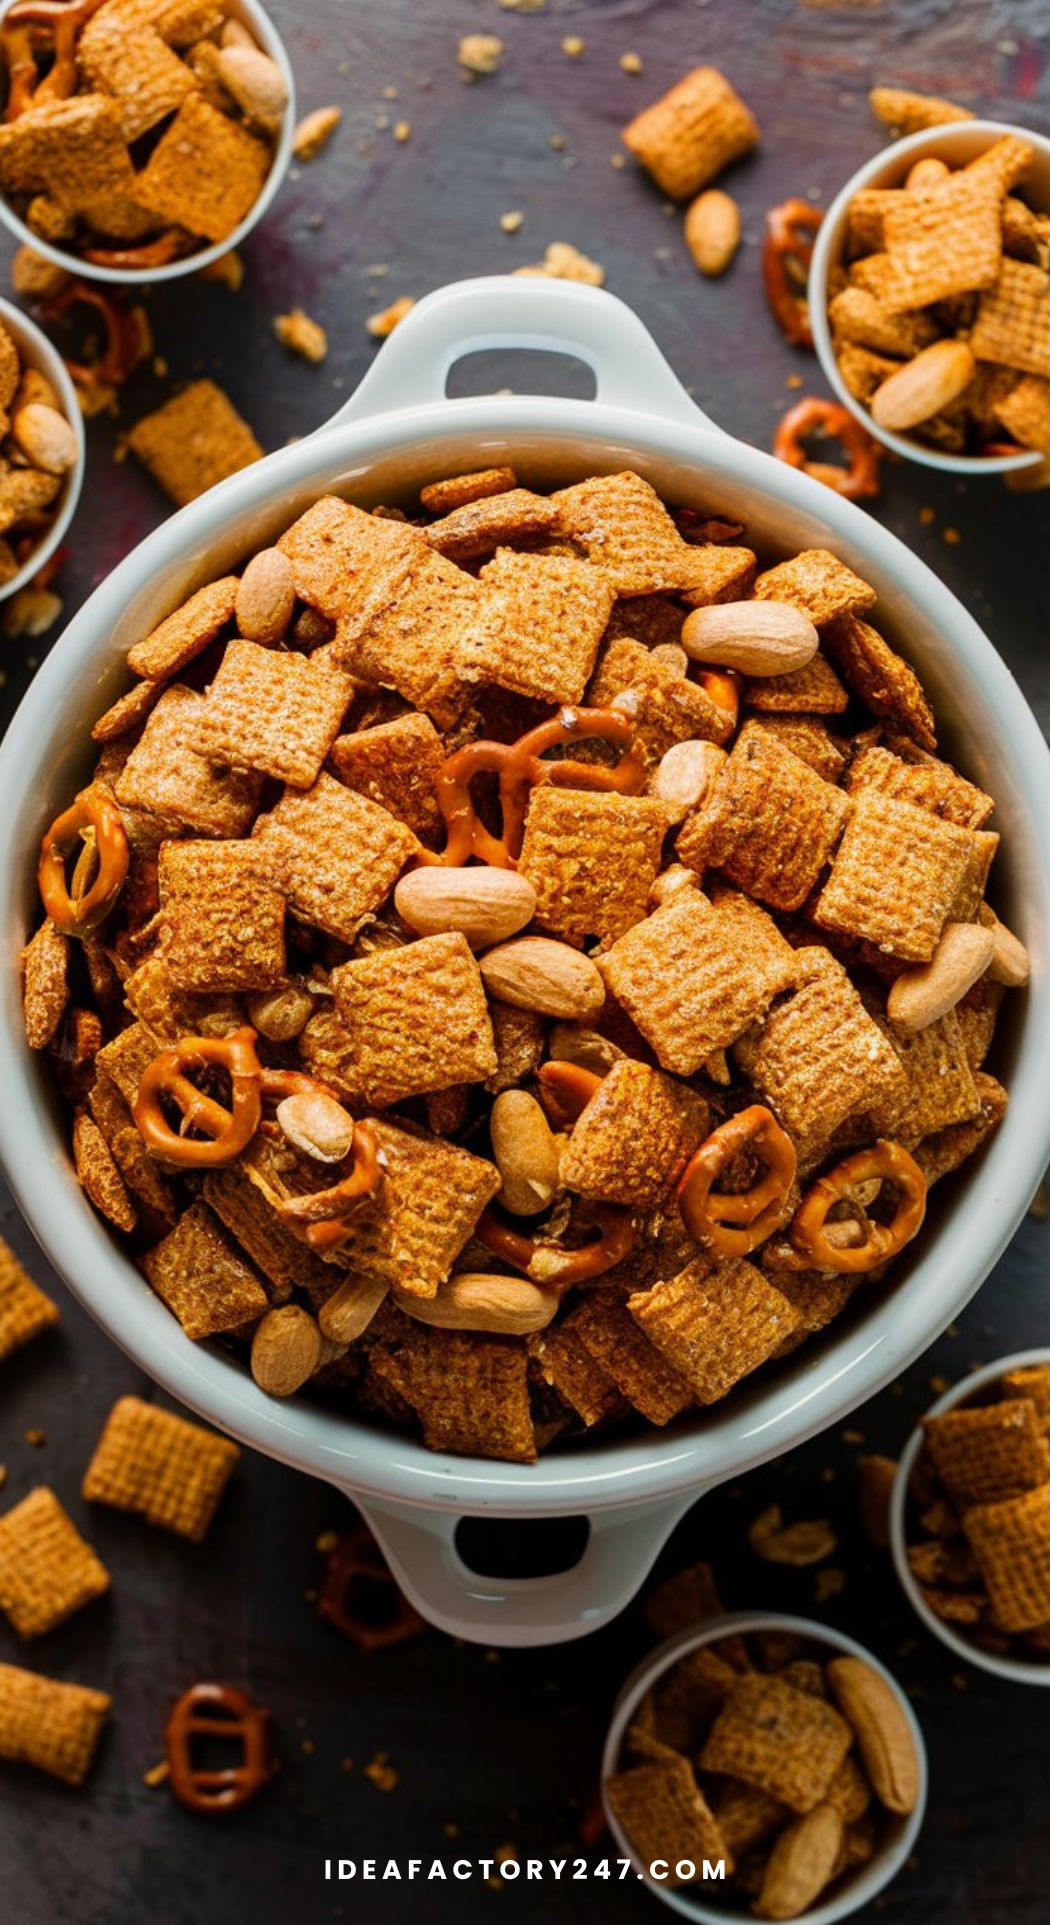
[{"x1": 678, "y1": 1103, "x2": 796, "y2": 1257}]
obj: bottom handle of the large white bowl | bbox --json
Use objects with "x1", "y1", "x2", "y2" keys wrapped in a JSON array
[{"x1": 347, "y1": 1490, "x2": 699, "y2": 1646}]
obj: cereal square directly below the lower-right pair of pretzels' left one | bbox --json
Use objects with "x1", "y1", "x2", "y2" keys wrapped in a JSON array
[{"x1": 628, "y1": 1257, "x2": 798, "y2": 1403}]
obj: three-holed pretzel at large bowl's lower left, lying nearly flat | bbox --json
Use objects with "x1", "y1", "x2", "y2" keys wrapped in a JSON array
[{"x1": 133, "y1": 1028, "x2": 262, "y2": 1168}]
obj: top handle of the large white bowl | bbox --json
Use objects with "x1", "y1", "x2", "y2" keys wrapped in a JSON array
[{"x1": 322, "y1": 273, "x2": 715, "y2": 433}]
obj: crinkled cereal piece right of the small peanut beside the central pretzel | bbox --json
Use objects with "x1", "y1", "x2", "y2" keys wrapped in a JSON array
[{"x1": 676, "y1": 722, "x2": 850, "y2": 911}]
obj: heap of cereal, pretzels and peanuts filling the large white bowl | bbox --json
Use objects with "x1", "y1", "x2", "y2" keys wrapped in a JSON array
[{"x1": 23, "y1": 468, "x2": 1027, "y2": 1461}]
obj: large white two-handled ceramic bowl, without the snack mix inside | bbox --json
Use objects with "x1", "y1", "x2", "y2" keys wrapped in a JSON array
[{"x1": 0, "y1": 275, "x2": 1050, "y2": 1644}]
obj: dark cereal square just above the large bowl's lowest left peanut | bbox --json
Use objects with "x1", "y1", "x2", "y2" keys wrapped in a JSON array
[{"x1": 143, "y1": 1201, "x2": 270, "y2": 1340}]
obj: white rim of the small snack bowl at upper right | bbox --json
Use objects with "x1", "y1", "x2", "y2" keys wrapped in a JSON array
[{"x1": 809, "y1": 119, "x2": 1050, "y2": 475}]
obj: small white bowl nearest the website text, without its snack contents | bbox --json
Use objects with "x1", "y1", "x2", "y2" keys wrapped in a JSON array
[{"x1": 601, "y1": 1611, "x2": 929, "y2": 1925}]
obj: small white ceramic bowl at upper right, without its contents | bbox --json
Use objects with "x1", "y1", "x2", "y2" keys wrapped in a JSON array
[{"x1": 809, "y1": 121, "x2": 1050, "y2": 475}]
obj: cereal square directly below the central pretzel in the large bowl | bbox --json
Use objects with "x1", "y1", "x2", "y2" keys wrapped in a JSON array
[{"x1": 518, "y1": 783, "x2": 669, "y2": 943}]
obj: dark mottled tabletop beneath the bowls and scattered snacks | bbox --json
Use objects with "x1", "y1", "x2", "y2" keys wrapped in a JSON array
[{"x1": 0, "y1": 0, "x2": 1050, "y2": 1925}]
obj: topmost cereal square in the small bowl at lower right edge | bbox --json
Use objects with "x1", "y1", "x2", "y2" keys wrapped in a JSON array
[{"x1": 923, "y1": 1398, "x2": 1050, "y2": 1511}]
